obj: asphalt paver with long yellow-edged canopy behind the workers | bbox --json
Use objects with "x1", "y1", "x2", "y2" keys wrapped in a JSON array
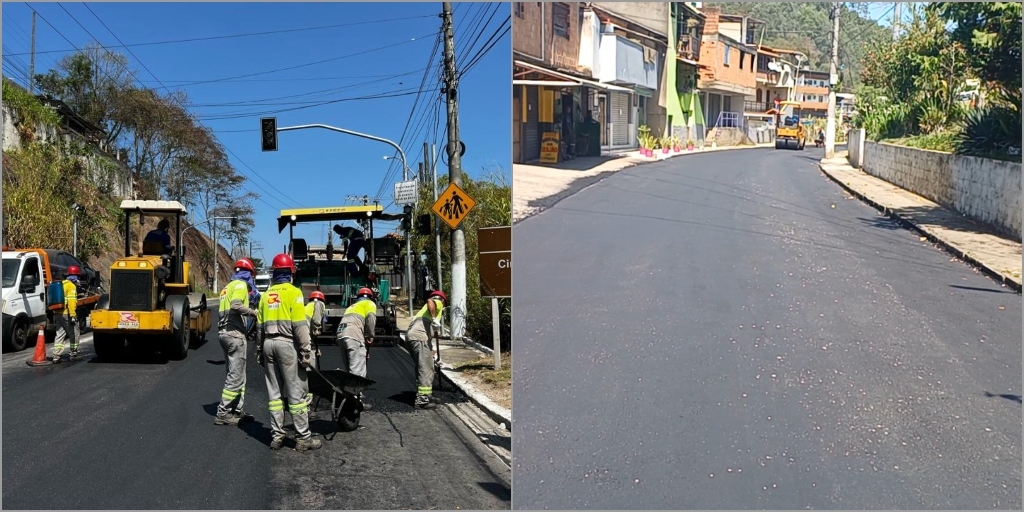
[{"x1": 278, "y1": 204, "x2": 409, "y2": 345}]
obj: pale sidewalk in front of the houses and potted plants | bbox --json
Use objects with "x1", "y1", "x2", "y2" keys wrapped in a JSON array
[{"x1": 512, "y1": 142, "x2": 774, "y2": 224}]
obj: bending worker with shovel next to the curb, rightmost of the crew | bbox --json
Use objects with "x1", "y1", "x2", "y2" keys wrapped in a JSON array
[{"x1": 406, "y1": 291, "x2": 447, "y2": 409}]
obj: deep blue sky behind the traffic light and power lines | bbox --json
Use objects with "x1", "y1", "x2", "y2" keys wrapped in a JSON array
[{"x1": 2, "y1": 2, "x2": 512, "y2": 266}]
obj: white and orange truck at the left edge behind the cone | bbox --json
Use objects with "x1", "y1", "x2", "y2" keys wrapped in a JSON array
[{"x1": 0, "y1": 247, "x2": 104, "y2": 351}]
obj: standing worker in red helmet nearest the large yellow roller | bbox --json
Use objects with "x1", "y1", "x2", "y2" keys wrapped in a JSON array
[{"x1": 213, "y1": 258, "x2": 256, "y2": 425}]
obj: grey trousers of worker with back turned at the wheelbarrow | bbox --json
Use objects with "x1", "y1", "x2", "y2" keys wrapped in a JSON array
[{"x1": 263, "y1": 338, "x2": 312, "y2": 439}]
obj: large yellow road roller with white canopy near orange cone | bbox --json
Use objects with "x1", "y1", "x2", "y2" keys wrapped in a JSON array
[{"x1": 90, "y1": 200, "x2": 212, "y2": 359}]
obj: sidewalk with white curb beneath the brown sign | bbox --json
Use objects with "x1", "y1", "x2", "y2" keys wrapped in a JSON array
[{"x1": 396, "y1": 308, "x2": 512, "y2": 430}]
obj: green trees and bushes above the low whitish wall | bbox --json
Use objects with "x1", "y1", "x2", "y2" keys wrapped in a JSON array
[{"x1": 854, "y1": 2, "x2": 1021, "y2": 162}]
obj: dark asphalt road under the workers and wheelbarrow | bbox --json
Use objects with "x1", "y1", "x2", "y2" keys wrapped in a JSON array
[{"x1": 3, "y1": 307, "x2": 511, "y2": 510}]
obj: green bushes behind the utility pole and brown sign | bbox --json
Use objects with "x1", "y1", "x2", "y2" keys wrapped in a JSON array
[{"x1": 413, "y1": 170, "x2": 512, "y2": 350}]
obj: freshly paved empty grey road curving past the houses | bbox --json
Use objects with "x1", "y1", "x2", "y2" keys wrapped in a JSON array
[{"x1": 513, "y1": 148, "x2": 1021, "y2": 510}]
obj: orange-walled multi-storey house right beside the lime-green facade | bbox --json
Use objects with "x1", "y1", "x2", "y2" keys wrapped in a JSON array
[{"x1": 697, "y1": 7, "x2": 764, "y2": 145}]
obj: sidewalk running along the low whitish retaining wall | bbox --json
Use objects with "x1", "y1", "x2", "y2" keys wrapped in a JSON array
[{"x1": 818, "y1": 152, "x2": 1021, "y2": 293}]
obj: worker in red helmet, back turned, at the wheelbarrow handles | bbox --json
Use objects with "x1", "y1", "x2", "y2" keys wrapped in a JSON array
[{"x1": 256, "y1": 254, "x2": 323, "y2": 452}]
